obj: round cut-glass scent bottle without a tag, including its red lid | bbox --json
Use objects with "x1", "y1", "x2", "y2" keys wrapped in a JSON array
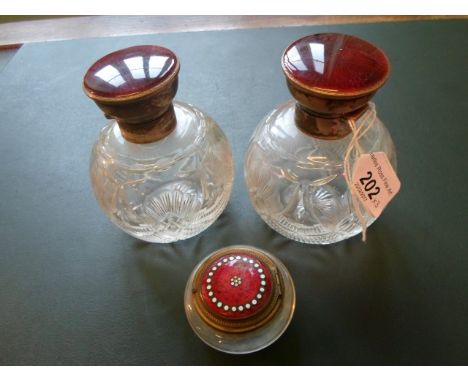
[{"x1": 83, "y1": 45, "x2": 234, "y2": 243}]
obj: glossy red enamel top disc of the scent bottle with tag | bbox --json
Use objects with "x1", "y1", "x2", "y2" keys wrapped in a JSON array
[{"x1": 282, "y1": 33, "x2": 390, "y2": 97}]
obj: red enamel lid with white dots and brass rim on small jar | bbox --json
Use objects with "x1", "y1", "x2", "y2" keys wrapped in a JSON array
[{"x1": 190, "y1": 246, "x2": 284, "y2": 333}]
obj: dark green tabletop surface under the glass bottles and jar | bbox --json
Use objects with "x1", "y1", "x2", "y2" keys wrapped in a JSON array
[{"x1": 0, "y1": 21, "x2": 468, "y2": 365}]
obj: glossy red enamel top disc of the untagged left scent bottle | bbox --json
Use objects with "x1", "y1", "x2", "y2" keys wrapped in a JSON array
[{"x1": 83, "y1": 45, "x2": 179, "y2": 101}]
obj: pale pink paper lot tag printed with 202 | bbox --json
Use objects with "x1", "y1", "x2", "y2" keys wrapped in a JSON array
[{"x1": 352, "y1": 152, "x2": 401, "y2": 218}]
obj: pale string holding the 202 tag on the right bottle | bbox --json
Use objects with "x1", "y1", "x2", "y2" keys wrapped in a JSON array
[{"x1": 343, "y1": 102, "x2": 377, "y2": 242}]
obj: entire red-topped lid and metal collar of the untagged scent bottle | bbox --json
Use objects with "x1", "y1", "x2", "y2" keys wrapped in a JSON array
[{"x1": 83, "y1": 45, "x2": 180, "y2": 143}]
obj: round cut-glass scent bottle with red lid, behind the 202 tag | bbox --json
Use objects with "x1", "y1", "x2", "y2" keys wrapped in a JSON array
[{"x1": 244, "y1": 33, "x2": 396, "y2": 244}]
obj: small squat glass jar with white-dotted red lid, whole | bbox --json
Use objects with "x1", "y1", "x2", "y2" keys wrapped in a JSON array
[{"x1": 185, "y1": 246, "x2": 295, "y2": 353}]
